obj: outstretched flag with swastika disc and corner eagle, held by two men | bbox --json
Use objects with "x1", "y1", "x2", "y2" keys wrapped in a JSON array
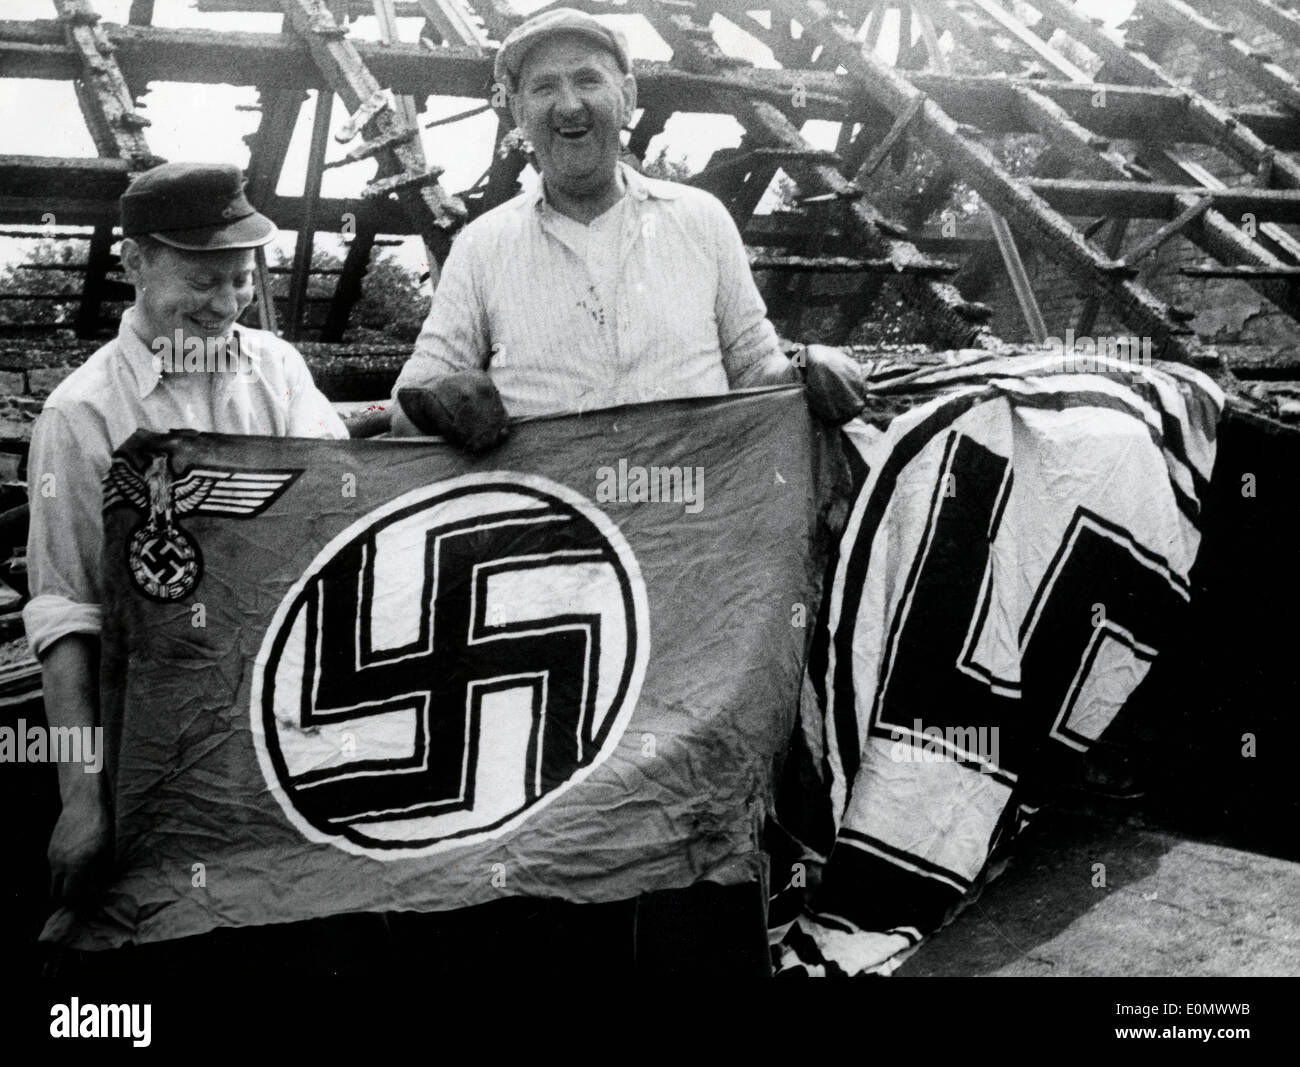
[{"x1": 46, "y1": 389, "x2": 842, "y2": 949}]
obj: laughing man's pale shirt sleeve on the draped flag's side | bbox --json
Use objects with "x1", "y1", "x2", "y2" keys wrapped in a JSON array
[{"x1": 710, "y1": 196, "x2": 798, "y2": 389}]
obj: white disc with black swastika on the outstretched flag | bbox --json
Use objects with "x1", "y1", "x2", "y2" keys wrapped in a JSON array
[{"x1": 250, "y1": 472, "x2": 650, "y2": 859}]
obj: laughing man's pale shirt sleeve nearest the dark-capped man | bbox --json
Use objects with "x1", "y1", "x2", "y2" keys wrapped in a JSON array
[{"x1": 393, "y1": 229, "x2": 490, "y2": 396}]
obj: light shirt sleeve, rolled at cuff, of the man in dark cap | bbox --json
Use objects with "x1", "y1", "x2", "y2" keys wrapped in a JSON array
[{"x1": 22, "y1": 405, "x2": 108, "y2": 656}]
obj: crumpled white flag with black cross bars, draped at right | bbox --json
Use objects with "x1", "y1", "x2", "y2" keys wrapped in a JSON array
[{"x1": 774, "y1": 354, "x2": 1223, "y2": 973}]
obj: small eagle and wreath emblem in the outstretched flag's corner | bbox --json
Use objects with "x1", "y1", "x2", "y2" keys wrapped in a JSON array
[{"x1": 104, "y1": 452, "x2": 302, "y2": 603}]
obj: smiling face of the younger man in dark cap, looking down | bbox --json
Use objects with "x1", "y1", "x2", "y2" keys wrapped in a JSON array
[{"x1": 122, "y1": 240, "x2": 254, "y2": 344}]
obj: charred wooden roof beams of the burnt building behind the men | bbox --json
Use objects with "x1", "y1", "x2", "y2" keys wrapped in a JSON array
[{"x1": 0, "y1": 0, "x2": 1300, "y2": 396}]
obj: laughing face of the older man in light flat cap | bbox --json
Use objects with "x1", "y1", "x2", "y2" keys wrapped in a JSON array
[{"x1": 511, "y1": 35, "x2": 637, "y2": 199}]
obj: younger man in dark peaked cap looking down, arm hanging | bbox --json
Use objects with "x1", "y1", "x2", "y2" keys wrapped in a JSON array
[{"x1": 23, "y1": 162, "x2": 347, "y2": 901}]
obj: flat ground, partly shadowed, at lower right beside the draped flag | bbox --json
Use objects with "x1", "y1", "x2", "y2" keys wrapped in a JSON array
[{"x1": 896, "y1": 811, "x2": 1300, "y2": 977}]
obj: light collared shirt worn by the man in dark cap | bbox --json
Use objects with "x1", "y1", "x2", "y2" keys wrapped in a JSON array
[{"x1": 22, "y1": 308, "x2": 347, "y2": 656}]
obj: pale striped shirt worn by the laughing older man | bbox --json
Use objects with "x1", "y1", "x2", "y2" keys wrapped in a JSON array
[{"x1": 397, "y1": 164, "x2": 797, "y2": 416}]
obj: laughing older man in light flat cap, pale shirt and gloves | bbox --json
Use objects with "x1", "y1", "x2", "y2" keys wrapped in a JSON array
[{"x1": 394, "y1": 8, "x2": 862, "y2": 436}]
